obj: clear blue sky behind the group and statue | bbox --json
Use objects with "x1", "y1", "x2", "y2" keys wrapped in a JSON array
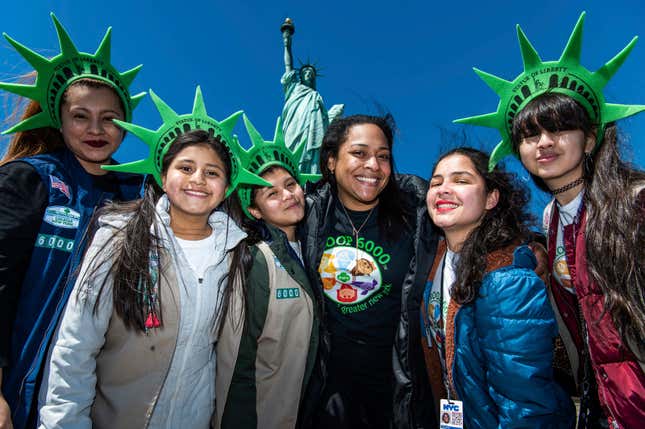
[{"x1": 0, "y1": 0, "x2": 645, "y2": 217}]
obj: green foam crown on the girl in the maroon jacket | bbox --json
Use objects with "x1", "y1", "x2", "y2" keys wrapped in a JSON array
[{"x1": 455, "y1": 12, "x2": 645, "y2": 170}]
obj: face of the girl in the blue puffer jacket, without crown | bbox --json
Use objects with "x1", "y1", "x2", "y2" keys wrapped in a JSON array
[{"x1": 426, "y1": 154, "x2": 499, "y2": 251}]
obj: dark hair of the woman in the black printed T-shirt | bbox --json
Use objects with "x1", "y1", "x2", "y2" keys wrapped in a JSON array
[{"x1": 320, "y1": 113, "x2": 413, "y2": 241}]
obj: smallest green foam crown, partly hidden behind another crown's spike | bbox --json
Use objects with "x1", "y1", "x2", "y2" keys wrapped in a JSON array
[{"x1": 237, "y1": 115, "x2": 322, "y2": 219}]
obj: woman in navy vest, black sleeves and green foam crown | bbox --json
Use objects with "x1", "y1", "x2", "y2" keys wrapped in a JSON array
[{"x1": 0, "y1": 14, "x2": 143, "y2": 429}]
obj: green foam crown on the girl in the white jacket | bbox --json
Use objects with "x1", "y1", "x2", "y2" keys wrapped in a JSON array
[{"x1": 101, "y1": 86, "x2": 271, "y2": 197}]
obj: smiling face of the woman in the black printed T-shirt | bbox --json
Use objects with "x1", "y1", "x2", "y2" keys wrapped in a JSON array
[{"x1": 327, "y1": 124, "x2": 392, "y2": 211}]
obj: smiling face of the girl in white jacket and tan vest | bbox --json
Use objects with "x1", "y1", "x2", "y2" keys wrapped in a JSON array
[{"x1": 162, "y1": 144, "x2": 228, "y2": 223}]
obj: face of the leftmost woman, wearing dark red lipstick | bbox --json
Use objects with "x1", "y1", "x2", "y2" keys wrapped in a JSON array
[{"x1": 60, "y1": 84, "x2": 124, "y2": 175}]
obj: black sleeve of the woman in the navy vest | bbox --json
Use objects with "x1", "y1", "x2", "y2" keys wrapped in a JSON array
[{"x1": 0, "y1": 162, "x2": 49, "y2": 368}]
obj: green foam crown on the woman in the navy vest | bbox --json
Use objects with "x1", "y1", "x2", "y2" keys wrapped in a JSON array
[{"x1": 0, "y1": 13, "x2": 145, "y2": 134}]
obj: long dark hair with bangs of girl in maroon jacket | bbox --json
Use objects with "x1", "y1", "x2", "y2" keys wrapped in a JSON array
[{"x1": 513, "y1": 93, "x2": 645, "y2": 344}]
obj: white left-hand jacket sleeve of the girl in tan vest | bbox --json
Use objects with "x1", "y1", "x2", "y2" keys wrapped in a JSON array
[{"x1": 38, "y1": 228, "x2": 113, "y2": 429}]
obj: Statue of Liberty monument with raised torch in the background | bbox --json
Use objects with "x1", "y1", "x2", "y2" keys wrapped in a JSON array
[{"x1": 280, "y1": 18, "x2": 344, "y2": 174}]
